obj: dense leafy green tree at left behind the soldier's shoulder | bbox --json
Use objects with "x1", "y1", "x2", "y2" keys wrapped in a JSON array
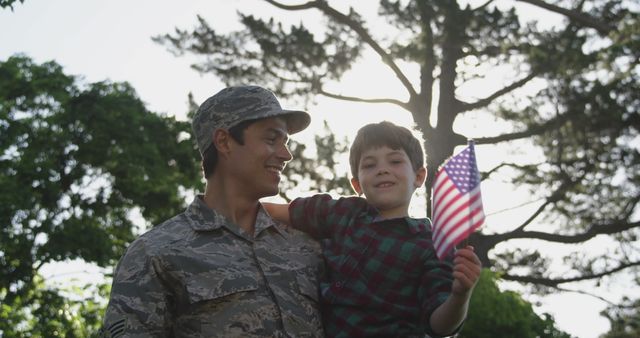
[{"x1": 0, "y1": 55, "x2": 201, "y2": 337}]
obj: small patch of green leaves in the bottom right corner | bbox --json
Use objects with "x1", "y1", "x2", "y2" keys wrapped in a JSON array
[{"x1": 600, "y1": 297, "x2": 640, "y2": 338}]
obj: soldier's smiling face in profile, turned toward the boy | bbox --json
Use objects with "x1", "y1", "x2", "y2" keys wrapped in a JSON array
[{"x1": 229, "y1": 117, "x2": 292, "y2": 198}]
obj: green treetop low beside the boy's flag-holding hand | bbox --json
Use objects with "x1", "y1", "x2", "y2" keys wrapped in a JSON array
[{"x1": 458, "y1": 269, "x2": 570, "y2": 338}]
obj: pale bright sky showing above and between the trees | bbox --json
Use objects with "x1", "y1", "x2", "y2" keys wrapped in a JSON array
[{"x1": 0, "y1": 0, "x2": 621, "y2": 338}]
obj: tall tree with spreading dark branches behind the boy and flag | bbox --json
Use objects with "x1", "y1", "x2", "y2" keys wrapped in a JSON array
[{"x1": 155, "y1": 0, "x2": 640, "y2": 302}]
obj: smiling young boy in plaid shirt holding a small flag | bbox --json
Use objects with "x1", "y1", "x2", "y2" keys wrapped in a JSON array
[{"x1": 263, "y1": 122, "x2": 481, "y2": 337}]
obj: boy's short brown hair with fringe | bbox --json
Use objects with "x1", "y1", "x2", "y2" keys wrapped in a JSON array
[{"x1": 349, "y1": 121, "x2": 425, "y2": 179}]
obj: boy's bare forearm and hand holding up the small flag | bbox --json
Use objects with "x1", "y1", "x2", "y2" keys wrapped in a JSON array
[{"x1": 429, "y1": 246, "x2": 482, "y2": 336}]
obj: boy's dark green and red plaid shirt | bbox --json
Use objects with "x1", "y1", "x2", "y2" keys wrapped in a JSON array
[{"x1": 289, "y1": 194, "x2": 453, "y2": 337}]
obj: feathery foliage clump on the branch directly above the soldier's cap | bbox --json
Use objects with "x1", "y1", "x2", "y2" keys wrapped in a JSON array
[{"x1": 154, "y1": 9, "x2": 361, "y2": 99}]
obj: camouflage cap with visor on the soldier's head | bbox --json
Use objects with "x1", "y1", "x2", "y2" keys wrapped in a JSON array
[{"x1": 191, "y1": 86, "x2": 311, "y2": 155}]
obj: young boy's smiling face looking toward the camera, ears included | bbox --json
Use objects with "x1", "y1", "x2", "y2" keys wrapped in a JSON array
[{"x1": 351, "y1": 146, "x2": 426, "y2": 218}]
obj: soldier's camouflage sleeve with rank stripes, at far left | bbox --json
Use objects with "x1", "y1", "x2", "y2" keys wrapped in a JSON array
[{"x1": 101, "y1": 243, "x2": 174, "y2": 337}]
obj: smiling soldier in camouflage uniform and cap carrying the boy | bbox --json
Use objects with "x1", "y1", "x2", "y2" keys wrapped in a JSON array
[{"x1": 101, "y1": 86, "x2": 323, "y2": 337}]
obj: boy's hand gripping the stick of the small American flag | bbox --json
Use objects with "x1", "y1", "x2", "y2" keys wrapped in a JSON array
[{"x1": 451, "y1": 245, "x2": 482, "y2": 296}]
